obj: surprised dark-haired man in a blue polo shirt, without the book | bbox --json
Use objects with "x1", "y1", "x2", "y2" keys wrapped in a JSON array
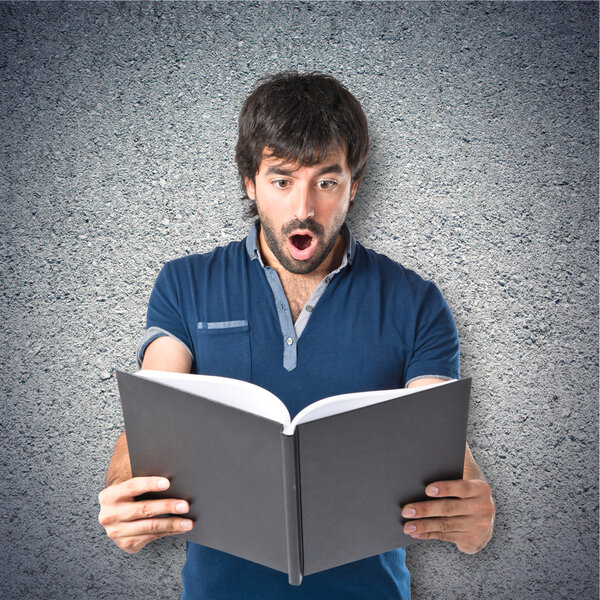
[{"x1": 99, "y1": 73, "x2": 494, "y2": 600}]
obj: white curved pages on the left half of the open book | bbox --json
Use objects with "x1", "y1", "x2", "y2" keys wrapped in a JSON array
[{"x1": 135, "y1": 369, "x2": 290, "y2": 428}]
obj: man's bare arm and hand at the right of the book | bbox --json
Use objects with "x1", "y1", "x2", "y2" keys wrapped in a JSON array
[{"x1": 402, "y1": 378, "x2": 495, "y2": 554}]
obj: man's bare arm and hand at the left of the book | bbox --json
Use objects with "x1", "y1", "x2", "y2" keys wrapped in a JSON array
[{"x1": 98, "y1": 336, "x2": 193, "y2": 553}]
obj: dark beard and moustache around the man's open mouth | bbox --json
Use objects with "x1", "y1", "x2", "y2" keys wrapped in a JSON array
[{"x1": 257, "y1": 206, "x2": 346, "y2": 275}]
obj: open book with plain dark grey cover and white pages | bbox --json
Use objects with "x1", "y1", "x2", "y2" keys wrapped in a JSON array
[{"x1": 117, "y1": 370, "x2": 471, "y2": 585}]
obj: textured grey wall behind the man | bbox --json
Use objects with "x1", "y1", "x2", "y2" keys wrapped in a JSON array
[{"x1": 0, "y1": 2, "x2": 598, "y2": 600}]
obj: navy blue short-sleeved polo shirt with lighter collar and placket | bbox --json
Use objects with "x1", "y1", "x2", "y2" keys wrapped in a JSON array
[{"x1": 138, "y1": 226, "x2": 459, "y2": 600}]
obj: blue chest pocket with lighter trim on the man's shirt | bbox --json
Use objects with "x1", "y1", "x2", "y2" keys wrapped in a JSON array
[{"x1": 196, "y1": 321, "x2": 252, "y2": 381}]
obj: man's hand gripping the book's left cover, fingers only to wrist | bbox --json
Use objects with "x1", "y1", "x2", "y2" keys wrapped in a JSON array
[{"x1": 98, "y1": 477, "x2": 194, "y2": 554}]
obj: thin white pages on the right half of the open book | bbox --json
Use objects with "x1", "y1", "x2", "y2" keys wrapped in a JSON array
[{"x1": 283, "y1": 379, "x2": 456, "y2": 435}]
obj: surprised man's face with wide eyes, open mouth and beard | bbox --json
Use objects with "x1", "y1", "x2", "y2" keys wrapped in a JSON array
[{"x1": 245, "y1": 149, "x2": 358, "y2": 274}]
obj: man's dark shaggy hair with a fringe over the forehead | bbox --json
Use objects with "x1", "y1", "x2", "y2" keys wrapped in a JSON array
[{"x1": 235, "y1": 71, "x2": 369, "y2": 217}]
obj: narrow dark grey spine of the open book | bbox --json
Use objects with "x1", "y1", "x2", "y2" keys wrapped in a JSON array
[{"x1": 281, "y1": 434, "x2": 302, "y2": 585}]
